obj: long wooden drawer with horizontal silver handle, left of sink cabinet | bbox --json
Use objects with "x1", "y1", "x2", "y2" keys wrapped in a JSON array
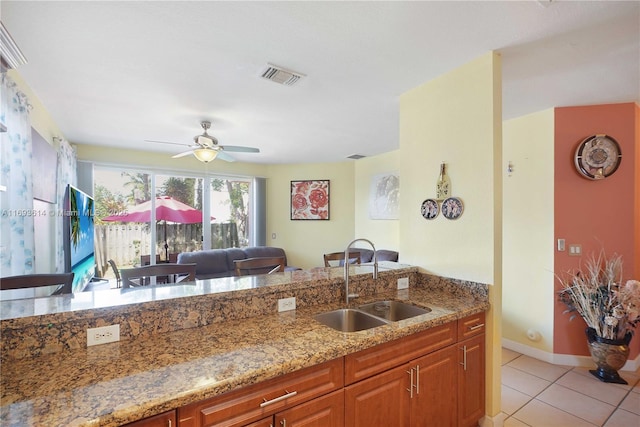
[{"x1": 178, "y1": 359, "x2": 343, "y2": 427}]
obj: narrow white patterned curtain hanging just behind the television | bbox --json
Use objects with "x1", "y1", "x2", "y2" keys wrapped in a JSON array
[{"x1": 55, "y1": 139, "x2": 78, "y2": 273}]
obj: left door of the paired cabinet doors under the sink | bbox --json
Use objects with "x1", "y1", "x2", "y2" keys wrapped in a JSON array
[{"x1": 344, "y1": 364, "x2": 410, "y2": 427}]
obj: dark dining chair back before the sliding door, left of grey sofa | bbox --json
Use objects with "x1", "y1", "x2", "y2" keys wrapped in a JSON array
[{"x1": 120, "y1": 263, "x2": 196, "y2": 288}]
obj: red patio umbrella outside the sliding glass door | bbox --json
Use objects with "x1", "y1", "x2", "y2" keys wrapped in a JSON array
[{"x1": 102, "y1": 196, "x2": 215, "y2": 260}]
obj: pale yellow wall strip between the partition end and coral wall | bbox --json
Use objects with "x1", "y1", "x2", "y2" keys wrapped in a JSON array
[{"x1": 502, "y1": 109, "x2": 554, "y2": 353}]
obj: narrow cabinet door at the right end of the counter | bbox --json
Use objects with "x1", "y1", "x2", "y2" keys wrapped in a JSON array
[{"x1": 458, "y1": 334, "x2": 485, "y2": 427}]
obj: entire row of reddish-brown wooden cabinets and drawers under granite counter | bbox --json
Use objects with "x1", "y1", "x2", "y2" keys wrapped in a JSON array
[{"x1": 165, "y1": 313, "x2": 485, "y2": 427}]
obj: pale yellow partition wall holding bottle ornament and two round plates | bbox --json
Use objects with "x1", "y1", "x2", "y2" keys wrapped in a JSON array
[{"x1": 400, "y1": 53, "x2": 502, "y2": 417}]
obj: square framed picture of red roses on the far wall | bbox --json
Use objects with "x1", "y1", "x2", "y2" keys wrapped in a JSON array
[{"x1": 291, "y1": 179, "x2": 329, "y2": 220}]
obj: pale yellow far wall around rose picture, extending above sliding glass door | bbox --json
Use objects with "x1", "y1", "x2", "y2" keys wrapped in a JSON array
[{"x1": 77, "y1": 145, "x2": 354, "y2": 269}]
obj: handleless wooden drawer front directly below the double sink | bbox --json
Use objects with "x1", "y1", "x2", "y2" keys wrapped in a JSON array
[{"x1": 344, "y1": 321, "x2": 457, "y2": 384}]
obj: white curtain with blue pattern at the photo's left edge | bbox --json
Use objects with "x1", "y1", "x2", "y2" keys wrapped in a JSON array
[{"x1": 0, "y1": 73, "x2": 34, "y2": 276}]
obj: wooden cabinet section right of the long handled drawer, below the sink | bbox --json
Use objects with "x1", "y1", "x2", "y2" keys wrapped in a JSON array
[{"x1": 345, "y1": 313, "x2": 485, "y2": 427}]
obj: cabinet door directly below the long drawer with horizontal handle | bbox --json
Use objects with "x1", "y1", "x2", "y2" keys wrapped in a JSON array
[{"x1": 274, "y1": 390, "x2": 344, "y2": 427}]
